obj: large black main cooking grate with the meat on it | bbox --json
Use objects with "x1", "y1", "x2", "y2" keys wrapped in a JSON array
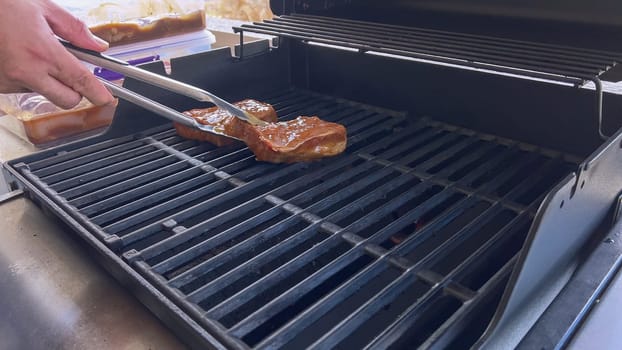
[{"x1": 15, "y1": 90, "x2": 576, "y2": 349}]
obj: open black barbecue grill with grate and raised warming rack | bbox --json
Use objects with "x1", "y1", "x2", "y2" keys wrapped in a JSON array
[{"x1": 8, "y1": 1, "x2": 622, "y2": 349}]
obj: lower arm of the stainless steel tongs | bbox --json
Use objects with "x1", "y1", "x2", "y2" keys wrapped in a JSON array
[{"x1": 100, "y1": 79, "x2": 237, "y2": 140}]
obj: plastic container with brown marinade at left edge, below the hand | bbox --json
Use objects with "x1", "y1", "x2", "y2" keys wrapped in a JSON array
[{"x1": 0, "y1": 93, "x2": 116, "y2": 148}]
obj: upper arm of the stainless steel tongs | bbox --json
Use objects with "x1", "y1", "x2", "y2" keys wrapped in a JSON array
[{"x1": 63, "y1": 43, "x2": 266, "y2": 125}]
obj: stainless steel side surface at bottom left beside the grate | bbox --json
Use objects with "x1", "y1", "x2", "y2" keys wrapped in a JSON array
[{"x1": 0, "y1": 198, "x2": 184, "y2": 349}]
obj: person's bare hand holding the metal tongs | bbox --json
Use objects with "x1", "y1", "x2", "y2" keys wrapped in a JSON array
[{"x1": 0, "y1": 0, "x2": 114, "y2": 108}]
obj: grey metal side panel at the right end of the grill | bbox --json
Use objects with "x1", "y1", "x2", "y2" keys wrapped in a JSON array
[{"x1": 477, "y1": 123, "x2": 622, "y2": 349}]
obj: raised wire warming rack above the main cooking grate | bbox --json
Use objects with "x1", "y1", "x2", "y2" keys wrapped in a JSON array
[{"x1": 234, "y1": 14, "x2": 622, "y2": 139}]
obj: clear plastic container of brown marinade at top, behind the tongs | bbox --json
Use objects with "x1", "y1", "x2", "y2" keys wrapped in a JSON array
[{"x1": 80, "y1": 0, "x2": 216, "y2": 81}]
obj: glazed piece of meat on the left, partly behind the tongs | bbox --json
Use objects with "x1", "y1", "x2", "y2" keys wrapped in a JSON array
[{"x1": 174, "y1": 99, "x2": 277, "y2": 147}]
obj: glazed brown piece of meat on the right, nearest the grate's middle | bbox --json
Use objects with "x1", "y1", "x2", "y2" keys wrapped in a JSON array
[{"x1": 225, "y1": 116, "x2": 347, "y2": 163}]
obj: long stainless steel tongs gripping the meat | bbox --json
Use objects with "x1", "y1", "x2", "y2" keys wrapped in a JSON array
[{"x1": 60, "y1": 40, "x2": 266, "y2": 138}]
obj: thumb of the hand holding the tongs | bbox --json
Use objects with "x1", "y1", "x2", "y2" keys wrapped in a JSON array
[{"x1": 45, "y1": 1, "x2": 108, "y2": 52}]
